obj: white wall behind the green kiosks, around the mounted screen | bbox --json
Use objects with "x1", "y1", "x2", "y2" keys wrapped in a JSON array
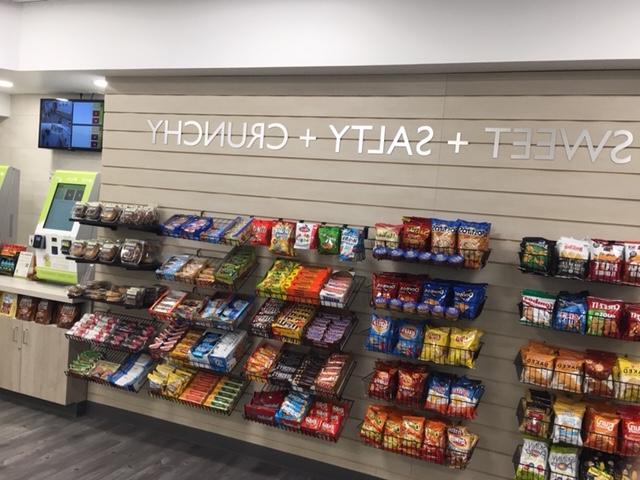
[{"x1": 0, "y1": 95, "x2": 101, "y2": 244}]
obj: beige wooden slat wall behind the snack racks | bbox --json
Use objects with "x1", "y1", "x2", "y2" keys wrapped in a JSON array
[{"x1": 90, "y1": 72, "x2": 640, "y2": 480}]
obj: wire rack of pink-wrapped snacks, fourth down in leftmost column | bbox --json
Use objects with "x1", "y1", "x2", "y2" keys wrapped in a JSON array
[{"x1": 65, "y1": 311, "x2": 160, "y2": 353}]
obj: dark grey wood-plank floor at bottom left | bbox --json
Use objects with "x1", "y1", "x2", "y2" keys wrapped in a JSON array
[{"x1": 0, "y1": 400, "x2": 315, "y2": 480}]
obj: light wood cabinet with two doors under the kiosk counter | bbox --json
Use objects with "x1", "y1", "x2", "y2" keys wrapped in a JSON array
[{"x1": 0, "y1": 317, "x2": 87, "y2": 405}]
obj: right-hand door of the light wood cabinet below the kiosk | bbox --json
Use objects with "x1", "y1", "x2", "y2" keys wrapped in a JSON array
[{"x1": 20, "y1": 322, "x2": 86, "y2": 405}]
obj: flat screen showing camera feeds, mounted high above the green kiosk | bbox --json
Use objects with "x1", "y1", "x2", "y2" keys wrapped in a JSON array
[{"x1": 38, "y1": 98, "x2": 104, "y2": 151}]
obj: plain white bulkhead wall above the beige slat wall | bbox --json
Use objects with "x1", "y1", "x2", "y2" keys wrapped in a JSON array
[{"x1": 0, "y1": 0, "x2": 640, "y2": 70}]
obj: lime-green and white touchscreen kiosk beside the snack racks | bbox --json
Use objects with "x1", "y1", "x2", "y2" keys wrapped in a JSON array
[{"x1": 30, "y1": 170, "x2": 99, "y2": 285}]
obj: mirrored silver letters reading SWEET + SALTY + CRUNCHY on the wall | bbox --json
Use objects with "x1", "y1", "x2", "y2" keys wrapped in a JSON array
[{"x1": 147, "y1": 120, "x2": 633, "y2": 164}]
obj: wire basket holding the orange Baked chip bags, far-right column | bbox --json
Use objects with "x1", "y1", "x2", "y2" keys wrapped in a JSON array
[{"x1": 514, "y1": 353, "x2": 640, "y2": 404}]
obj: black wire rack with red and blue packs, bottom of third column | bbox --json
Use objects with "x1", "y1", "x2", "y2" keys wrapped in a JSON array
[{"x1": 243, "y1": 385, "x2": 354, "y2": 443}]
